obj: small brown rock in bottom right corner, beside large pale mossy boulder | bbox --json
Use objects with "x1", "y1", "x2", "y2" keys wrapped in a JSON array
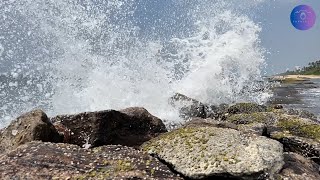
[{"x1": 278, "y1": 153, "x2": 320, "y2": 180}]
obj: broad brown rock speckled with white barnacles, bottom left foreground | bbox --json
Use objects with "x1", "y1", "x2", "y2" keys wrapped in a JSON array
[{"x1": 0, "y1": 142, "x2": 180, "y2": 179}]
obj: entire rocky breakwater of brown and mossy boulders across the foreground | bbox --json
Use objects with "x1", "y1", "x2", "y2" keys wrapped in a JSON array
[{"x1": 0, "y1": 94, "x2": 320, "y2": 179}]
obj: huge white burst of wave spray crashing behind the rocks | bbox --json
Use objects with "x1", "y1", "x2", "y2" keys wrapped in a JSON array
[{"x1": 0, "y1": 0, "x2": 269, "y2": 127}]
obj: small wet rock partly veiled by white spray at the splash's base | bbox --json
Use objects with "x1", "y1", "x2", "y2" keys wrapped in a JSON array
[{"x1": 170, "y1": 93, "x2": 209, "y2": 119}]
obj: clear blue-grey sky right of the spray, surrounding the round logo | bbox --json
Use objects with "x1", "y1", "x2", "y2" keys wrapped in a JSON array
[{"x1": 256, "y1": 0, "x2": 320, "y2": 74}]
